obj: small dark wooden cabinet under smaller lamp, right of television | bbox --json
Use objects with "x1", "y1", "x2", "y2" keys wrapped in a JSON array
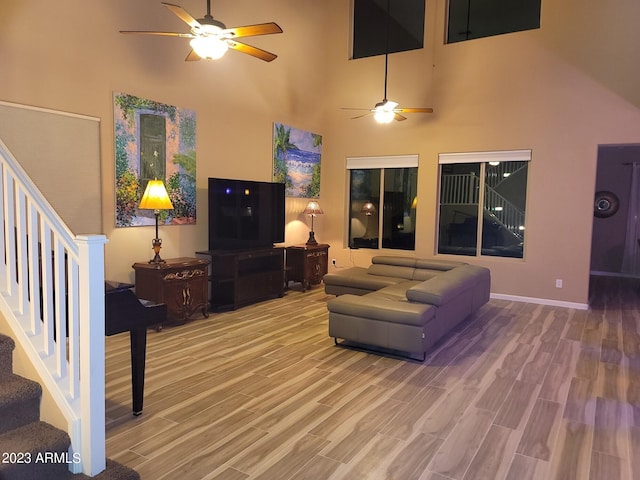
[{"x1": 287, "y1": 244, "x2": 329, "y2": 291}]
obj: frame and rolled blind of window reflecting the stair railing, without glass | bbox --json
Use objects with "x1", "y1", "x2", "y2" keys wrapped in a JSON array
[{"x1": 435, "y1": 149, "x2": 532, "y2": 261}]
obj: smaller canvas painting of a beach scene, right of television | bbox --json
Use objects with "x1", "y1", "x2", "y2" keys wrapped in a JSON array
[{"x1": 273, "y1": 123, "x2": 322, "y2": 198}]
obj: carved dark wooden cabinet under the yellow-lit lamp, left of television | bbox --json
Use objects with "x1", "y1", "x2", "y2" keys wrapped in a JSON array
[{"x1": 133, "y1": 257, "x2": 209, "y2": 322}]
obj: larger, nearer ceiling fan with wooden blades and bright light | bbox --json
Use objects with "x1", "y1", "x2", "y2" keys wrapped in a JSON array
[{"x1": 120, "y1": 0, "x2": 282, "y2": 62}]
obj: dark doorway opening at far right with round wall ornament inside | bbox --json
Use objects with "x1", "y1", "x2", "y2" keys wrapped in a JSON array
[{"x1": 591, "y1": 144, "x2": 640, "y2": 277}]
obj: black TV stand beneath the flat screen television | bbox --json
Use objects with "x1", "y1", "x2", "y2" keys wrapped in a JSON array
[{"x1": 196, "y1": 247, "x2": 285, "y2": 311}]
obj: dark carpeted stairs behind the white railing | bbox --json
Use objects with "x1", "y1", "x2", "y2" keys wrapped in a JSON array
[{"x1": 0, "y1": 335, "x2": 140, "y2": 480}]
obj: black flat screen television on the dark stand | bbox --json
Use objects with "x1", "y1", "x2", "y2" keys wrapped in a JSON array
[{"x1": 208, "y1": 178, "x2": 285, "y2": 250}]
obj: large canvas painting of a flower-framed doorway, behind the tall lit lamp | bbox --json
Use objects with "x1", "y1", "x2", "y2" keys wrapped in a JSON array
[{"x1": 113, "y1": 93, "x2": 196, "y2": 227}]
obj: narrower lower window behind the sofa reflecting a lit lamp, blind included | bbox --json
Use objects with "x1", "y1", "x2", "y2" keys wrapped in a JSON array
[{"x1": 347, "y1": 155, "x2": 418, "y2": 250}]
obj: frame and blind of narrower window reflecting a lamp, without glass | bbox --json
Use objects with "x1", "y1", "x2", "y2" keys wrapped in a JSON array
[{"x1": 345, "y1": 154, "x2": 419, "y2": 251}]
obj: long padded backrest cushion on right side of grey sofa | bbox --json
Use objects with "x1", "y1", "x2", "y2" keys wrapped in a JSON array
[{"x1": 407, "y1": 265, "x2": 489, "y2": 306}]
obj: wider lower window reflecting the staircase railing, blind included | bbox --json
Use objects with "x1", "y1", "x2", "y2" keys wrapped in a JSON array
[{"x1": 438, "y1": 150, "x2": 531, "y2": 258}]
